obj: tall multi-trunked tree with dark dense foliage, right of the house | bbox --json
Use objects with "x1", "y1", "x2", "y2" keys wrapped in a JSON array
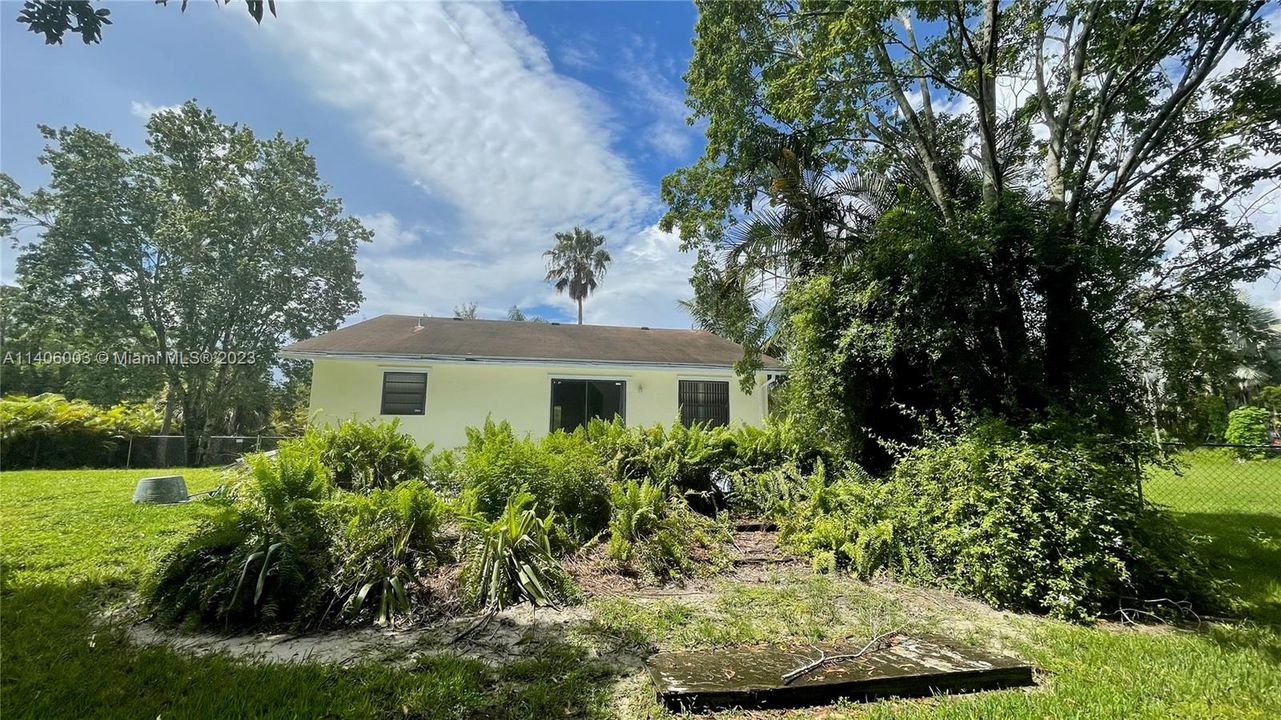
[{"x1": 664, "y1": 0, "x2": 1281, "y2": 453}]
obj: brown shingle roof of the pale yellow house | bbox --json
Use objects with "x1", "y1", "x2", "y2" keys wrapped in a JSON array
[{"x1": 284, "y1": 315, "x2": 781, "y2": 368}]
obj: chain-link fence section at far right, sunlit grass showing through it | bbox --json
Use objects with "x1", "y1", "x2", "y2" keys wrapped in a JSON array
[{"x1": 1143, "y1": 443, "x2": 1281, "y2": 518}]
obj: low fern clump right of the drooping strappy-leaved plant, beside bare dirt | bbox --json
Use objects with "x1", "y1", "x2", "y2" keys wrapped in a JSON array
[{"x1": 606, "y1": 480, "x2": 725, "y2": 582}]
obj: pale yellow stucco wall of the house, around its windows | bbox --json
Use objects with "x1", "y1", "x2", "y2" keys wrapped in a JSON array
[{"x1": 311, "y1": 359, "x2": 766, "y2": 448}]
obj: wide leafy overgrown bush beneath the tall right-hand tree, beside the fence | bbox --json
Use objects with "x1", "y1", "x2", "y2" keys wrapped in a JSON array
[{"x1": 784, "y1": 422, "x2": 1216, "y2": 619}]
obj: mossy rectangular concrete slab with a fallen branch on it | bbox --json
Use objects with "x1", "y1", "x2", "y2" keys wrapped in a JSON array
[{"x1": 646, "y1": 635, "x2": 1034, "y2": 711}]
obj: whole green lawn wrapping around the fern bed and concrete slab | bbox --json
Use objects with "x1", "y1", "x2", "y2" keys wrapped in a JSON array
[{"x1": 0, "y1": 461, "x2": 1281, "y2": 719}]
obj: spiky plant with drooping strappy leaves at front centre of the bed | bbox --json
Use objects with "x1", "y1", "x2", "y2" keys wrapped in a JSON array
[{"x1": 462, "y1": 492, "x2": 573, "y2": 610}]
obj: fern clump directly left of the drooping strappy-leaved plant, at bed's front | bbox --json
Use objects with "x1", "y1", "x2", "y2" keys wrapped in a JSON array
[{"x1": 330, "y1": 480, "x2": 448, "y2": 625}]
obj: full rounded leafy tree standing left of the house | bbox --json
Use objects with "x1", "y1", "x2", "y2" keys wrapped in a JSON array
[{"x1": 0, "y1": 101, "x2": 371, "y2": 453}]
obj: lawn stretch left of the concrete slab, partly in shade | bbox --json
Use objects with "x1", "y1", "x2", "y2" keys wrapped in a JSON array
[{"x1": 0, "y1": 469, "x2": 611, "y2": 720}]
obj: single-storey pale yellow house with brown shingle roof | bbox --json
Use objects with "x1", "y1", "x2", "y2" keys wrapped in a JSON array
[{"x1": 283, "y1": 315, "x2": 781, "y2": 447}]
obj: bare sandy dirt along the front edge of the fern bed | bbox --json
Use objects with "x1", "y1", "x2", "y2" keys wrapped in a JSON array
[{"x1": 122, "y1": 529, "x2": 1026, "y2": 673}]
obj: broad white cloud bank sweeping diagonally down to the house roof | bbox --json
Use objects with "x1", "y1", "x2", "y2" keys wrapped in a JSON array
[{"x1": 254, "y1": 3, "x2": 692, "y2": 327}]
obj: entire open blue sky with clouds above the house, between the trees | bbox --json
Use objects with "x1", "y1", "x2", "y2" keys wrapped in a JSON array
[{"x1": 0, "y1": 0, "x2": 702, "y2": 327}]
